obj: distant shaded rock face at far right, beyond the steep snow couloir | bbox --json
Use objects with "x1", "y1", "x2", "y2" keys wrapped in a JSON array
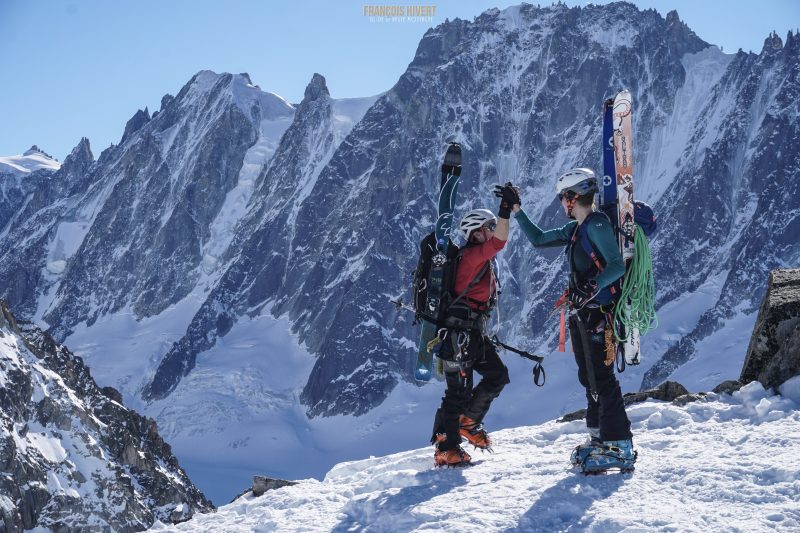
[{"x1": 642, "y1": 28, "x2": 800, "y2": 388}]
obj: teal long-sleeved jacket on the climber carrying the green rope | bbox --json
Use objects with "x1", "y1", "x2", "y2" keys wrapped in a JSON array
[{"x1": 514, "y1": 209, "x2": 625, "y2": 289}]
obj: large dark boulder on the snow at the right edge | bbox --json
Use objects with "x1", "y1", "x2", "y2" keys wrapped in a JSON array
[{"x1": 739, "y1": 269, "x2": 800, "y2": 389}]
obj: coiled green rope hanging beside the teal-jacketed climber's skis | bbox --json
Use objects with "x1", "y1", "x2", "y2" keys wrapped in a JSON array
[{"x1": 614, "y1": 225, "x2": 658, "y2": 343}]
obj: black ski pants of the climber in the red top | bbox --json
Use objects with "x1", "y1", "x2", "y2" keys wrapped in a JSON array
[{"x1": 431, "y1": 331, "x2": 510, "y2": 450}]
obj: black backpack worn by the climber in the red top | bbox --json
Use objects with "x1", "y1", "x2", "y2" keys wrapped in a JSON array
[{"x1": 412, "y1": 232, "x2": 491, "y2": 325}]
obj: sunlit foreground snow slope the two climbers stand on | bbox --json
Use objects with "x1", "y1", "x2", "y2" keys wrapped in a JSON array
[{"x1": 152, "y1": 376, "x2": 800, "y2": 532}]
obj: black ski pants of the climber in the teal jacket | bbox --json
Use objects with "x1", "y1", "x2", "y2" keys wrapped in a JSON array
[{"x1": 569, "y1": 308, "x2": 632, "y2": 441}]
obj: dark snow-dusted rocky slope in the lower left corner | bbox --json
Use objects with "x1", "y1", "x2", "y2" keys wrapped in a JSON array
[{"x1": 0, "y1": 300, "x2": 213, "y2": 532}]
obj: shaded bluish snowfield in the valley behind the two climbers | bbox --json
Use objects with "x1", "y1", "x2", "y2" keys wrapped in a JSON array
[{"x1": 61, "y1": 286, "x2": 755, "y2": 505}]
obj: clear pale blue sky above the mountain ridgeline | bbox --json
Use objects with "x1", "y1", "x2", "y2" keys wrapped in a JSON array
[{"x1": 0, "y1": 0, "x2": 800, "y2": 160}]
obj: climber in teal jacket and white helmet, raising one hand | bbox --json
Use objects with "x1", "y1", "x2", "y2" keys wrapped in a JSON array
[{"x1": 506, "y1": 168, "x2": 636, "y2": 473}]
